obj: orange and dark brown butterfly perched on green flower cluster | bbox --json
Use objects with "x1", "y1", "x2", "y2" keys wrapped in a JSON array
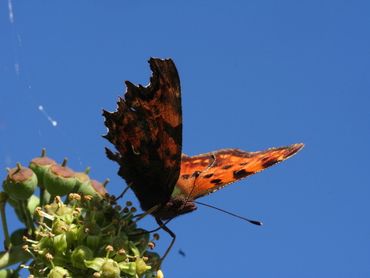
[{"x1": 103, "y1": 58, "x2": 304, "y2": 258}]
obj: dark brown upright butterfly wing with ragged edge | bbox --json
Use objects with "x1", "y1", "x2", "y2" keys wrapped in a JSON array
[{"x1": 103, "y1": 58, "x2": 182, "y2": 210}]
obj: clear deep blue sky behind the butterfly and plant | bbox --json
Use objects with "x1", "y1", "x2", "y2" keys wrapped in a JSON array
[{"x1": 0, "y1": 0, "x2": 370, "y2": 278}]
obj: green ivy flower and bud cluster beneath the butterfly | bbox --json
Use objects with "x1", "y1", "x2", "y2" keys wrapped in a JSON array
[{"x1": 0, "y1": 151, "x2": 163, "y2": 278}]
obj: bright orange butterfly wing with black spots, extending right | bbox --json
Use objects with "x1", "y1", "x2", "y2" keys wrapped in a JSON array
[{"x1": 173, "y1": 144, "x2": 304, "y2": 199}]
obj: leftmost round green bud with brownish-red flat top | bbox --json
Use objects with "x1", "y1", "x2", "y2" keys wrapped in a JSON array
[{"x1": 3, "y1": 164, "x2": 37, "y2": 200}]
